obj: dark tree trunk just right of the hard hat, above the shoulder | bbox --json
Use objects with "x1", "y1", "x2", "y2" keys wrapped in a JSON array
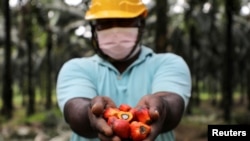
[{"x1": 155, "y1": 0, "x2": 168, "y2": 53}]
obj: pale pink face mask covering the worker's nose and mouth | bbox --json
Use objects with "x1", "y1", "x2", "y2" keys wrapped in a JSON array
[{"x1": 97, "y1": 27, "x2": 139, "y2": 60}]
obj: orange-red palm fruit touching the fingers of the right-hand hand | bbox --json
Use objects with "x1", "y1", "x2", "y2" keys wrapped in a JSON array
[{"x1": 134, "y1": 107, "x2": 151, "y2": 124}]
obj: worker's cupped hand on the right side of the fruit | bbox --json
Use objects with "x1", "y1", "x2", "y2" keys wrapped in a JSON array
[{"x1": 135, "y1": 94, "x2": 167, "y2": 141}]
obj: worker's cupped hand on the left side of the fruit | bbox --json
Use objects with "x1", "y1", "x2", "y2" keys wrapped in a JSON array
[{"x1": 88, "y1": 96, "x2": 121, "y2": 141}]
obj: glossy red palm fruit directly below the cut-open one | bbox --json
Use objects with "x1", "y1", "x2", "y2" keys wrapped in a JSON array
[{"x1": 108, "y1": 117, "x2": 130, "y2": 139}]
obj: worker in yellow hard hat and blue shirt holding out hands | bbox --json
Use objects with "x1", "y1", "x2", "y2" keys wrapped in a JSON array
[{"x1": 56, "y1": 0, "x2": 191, "y2": 141}]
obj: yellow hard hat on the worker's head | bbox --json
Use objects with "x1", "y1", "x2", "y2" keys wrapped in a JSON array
[{"x1": 85, "y1": 0, "x2": 148, "y2": 20}]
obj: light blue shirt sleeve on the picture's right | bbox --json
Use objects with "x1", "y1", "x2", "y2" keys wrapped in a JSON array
[{"x1": 152, "y1": 53, "x2": 191, "y2": 108}]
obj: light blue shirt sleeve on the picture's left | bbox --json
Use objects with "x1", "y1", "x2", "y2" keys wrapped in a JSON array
[{"x1": 56, "y1": 59, "x2": 96, "y2": 112}]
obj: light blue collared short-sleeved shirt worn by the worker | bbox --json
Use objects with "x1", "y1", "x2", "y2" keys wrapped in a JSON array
[{"x1": 57, "y1": 46, "x2": 191, "y2": 141}]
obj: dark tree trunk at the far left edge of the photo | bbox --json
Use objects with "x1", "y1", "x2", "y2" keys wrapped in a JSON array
[{"x1": 1, "y1": 0, "x2": 13, "y2": 118}]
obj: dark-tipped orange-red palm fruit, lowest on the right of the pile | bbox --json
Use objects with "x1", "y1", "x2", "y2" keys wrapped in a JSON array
[{"x1": 130, "y1": 121, "x2": 151, "y2": 141}]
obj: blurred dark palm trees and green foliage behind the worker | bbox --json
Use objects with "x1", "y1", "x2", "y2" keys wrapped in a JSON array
[{"x1": 0, "y1": 0, "x2": 250, "y2": 140}]
